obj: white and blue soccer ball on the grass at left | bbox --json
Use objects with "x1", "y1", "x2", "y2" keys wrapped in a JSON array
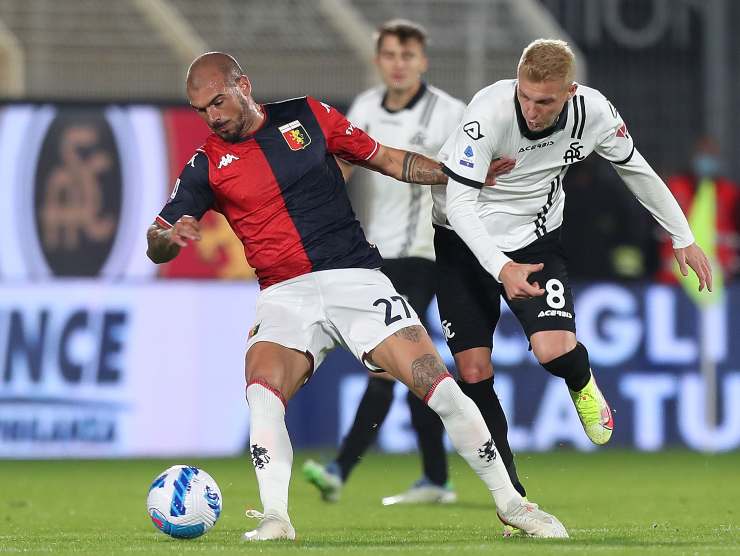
[{"x1": 146, "y1": 465, "x2": 221, "y2": 539}]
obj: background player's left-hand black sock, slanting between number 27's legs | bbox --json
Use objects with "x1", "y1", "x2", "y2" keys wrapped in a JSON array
[{"x1": 335, "y1": 377, "x2": 396, "y2": 481}]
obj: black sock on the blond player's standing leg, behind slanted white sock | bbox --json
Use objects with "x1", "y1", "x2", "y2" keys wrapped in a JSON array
[{"x1": 458, "y1": 377, "x2": 527, "y2": 496}]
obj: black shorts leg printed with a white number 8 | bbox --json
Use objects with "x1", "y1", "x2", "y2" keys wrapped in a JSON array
[{"x1": 506, "y1": 239, "x2": 576, "y2": 341}]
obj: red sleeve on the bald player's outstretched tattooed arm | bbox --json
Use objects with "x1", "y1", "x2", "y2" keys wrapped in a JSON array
[{"x1": 307, "y1": 97, "x2": 379, "y2": 163}]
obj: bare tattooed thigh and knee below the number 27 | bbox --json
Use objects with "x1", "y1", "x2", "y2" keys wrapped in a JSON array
[{"x1": 369, "y1": 326, "x2": 449, "y2": 399}]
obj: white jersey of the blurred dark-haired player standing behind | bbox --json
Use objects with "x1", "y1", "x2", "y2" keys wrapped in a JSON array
[{"x1": 347, "y1": 85, "x2": 465, "y2": 259}]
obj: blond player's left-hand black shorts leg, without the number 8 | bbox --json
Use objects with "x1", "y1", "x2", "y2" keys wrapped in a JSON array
[{"x1": 434, "y1": 226, "x2": 502, "y2": 355}]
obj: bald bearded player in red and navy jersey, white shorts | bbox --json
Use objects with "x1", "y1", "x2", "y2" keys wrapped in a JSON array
[{"x1": 147, "y1": 52, "x2": 567, "y2": 541}]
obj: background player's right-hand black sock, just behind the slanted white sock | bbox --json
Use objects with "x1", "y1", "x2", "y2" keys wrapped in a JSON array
[{"x1": 406, "y1": 391, "x2": 447, "y2": 486}]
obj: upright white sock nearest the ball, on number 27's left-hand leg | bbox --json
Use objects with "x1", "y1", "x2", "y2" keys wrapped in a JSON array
[{"x1": 247, "y1": 382, "x2": 293, "y2": 520}]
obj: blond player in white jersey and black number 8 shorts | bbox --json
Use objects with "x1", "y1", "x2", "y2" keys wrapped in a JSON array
[{"x1": 434, "y1": 40, "x2": 712, "y2": 444}]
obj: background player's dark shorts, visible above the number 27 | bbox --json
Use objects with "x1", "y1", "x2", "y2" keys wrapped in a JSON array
[{"x1": 380, "y1": 257, "x2": 437, "y2": 326}]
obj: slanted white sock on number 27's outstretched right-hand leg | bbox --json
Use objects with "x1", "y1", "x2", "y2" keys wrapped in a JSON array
[{"x1": 425, "y1": 375, "x2": 521, "y2": 511}]
